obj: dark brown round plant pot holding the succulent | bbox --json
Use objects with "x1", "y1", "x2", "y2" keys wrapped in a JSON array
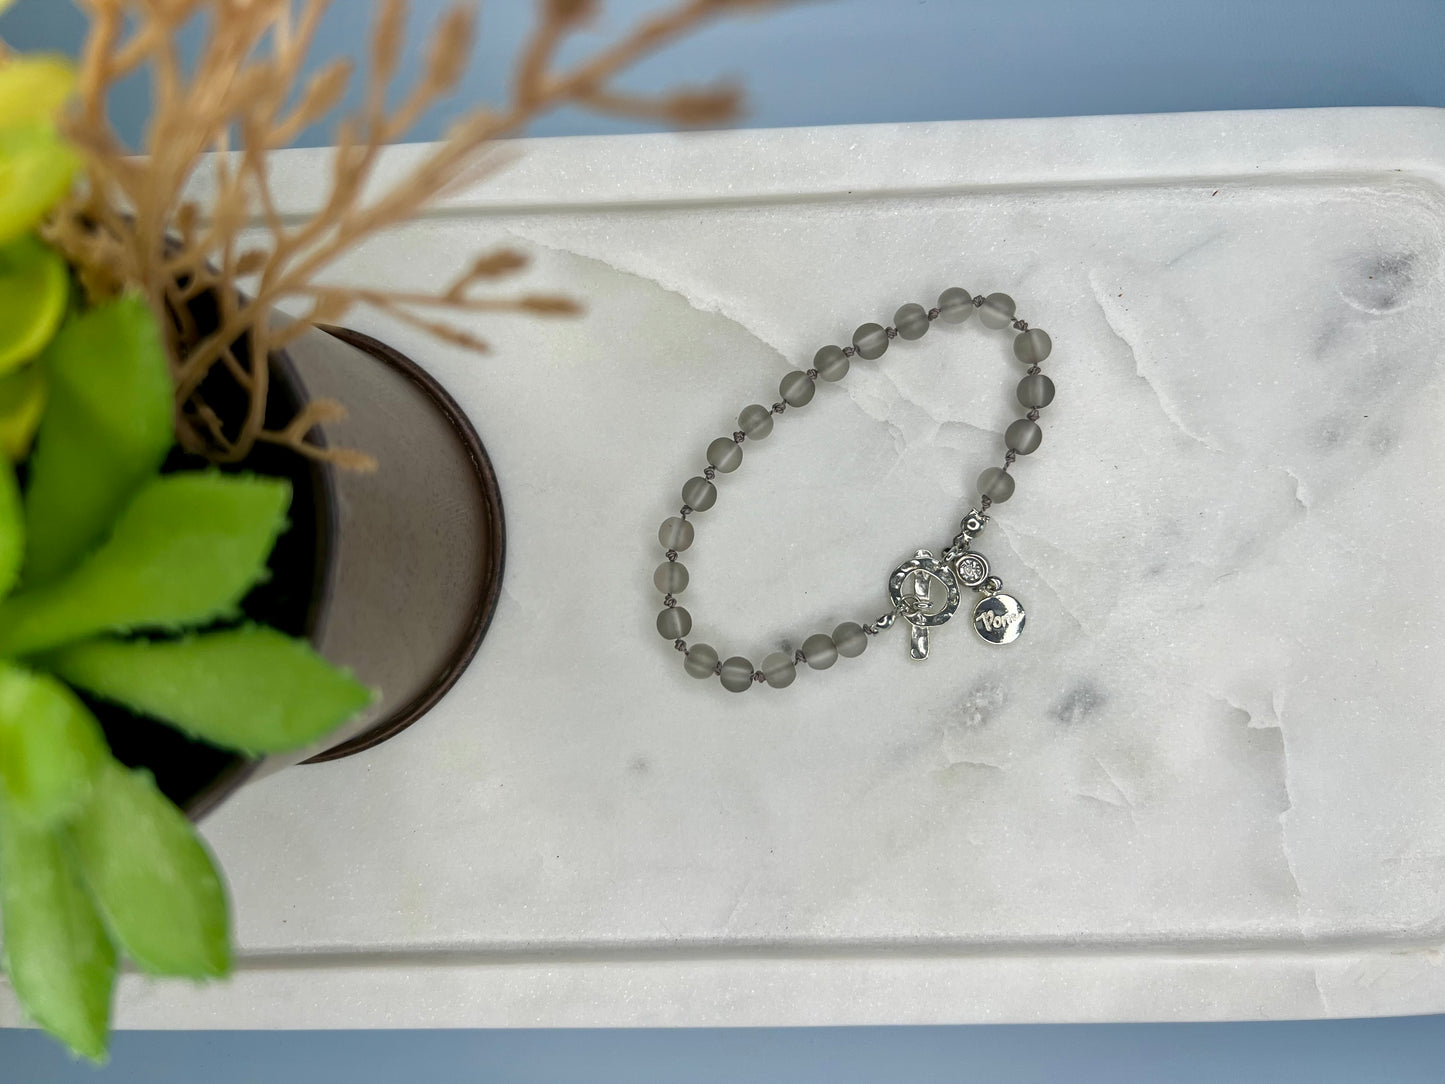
[{"x1": 90, "y1": 317, "x2": 506, "y2": 818}]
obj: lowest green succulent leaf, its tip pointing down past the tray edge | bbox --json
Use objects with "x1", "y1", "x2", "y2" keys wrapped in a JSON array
[{"x1": 0, "y1": 815, "x2": 116, "y2": 1061}]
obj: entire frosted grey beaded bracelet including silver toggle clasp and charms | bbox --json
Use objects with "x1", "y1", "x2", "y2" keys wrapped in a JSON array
[{"x1": 653, "y1": 286, "x2": 1053, "y2": 692}]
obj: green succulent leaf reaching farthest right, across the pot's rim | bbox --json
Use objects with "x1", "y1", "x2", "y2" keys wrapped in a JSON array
[{"x1": 45, "y1": 626, "x2": 371, "y2": 754}]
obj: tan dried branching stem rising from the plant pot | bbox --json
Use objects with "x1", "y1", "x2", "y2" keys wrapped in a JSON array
[{"x1": 48, "y1": 0, "x2": 766, "y2": 467}]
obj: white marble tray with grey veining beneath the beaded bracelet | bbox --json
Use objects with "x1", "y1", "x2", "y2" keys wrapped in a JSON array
[{"x1": 11, "y1": 110, "x2": 1445, "y2": 1028}]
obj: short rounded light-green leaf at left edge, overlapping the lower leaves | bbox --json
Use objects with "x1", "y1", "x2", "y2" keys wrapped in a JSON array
[{"x1": 0, "y1": 661, "x2": 110, "y2": 825}]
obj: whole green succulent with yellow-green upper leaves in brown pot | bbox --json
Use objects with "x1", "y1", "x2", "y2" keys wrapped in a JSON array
[{"x1": 0, "y1": 50, "x2": 371, "y2": 1059}]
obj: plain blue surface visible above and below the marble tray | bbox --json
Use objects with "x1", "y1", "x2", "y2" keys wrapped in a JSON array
[{"x1": 0, "y1": 0, "x2": 1445, "y2": 1084}]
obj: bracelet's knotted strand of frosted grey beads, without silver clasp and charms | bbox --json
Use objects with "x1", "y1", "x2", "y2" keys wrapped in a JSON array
[{"x1": 653, "y1": 286, "x2": 1055, "y2": 692}]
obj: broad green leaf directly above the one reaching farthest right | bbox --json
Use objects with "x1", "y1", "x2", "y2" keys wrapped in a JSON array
[{"x1": 0, "y1": 471, "x2": 290, "y2": 656}]
